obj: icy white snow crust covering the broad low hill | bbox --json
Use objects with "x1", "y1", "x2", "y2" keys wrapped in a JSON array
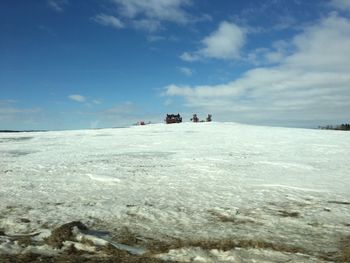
[{"x1": 0, "y1": 123, "x2": 350, "y2": 262}]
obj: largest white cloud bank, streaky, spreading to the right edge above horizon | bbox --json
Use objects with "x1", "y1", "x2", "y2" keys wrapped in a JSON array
[{"x1": 165, "y1": 14, "x2": 350, "y2": 127}]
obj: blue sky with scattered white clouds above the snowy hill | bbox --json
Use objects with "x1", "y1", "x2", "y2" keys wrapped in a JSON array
[{"x1": 0, "y1": 0, "x2": 350, "y2": 130}]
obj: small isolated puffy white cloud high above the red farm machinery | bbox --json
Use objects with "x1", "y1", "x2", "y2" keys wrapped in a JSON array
[{"x1": 180, "y1": 21, "x2": 245, "y2": 61}]
